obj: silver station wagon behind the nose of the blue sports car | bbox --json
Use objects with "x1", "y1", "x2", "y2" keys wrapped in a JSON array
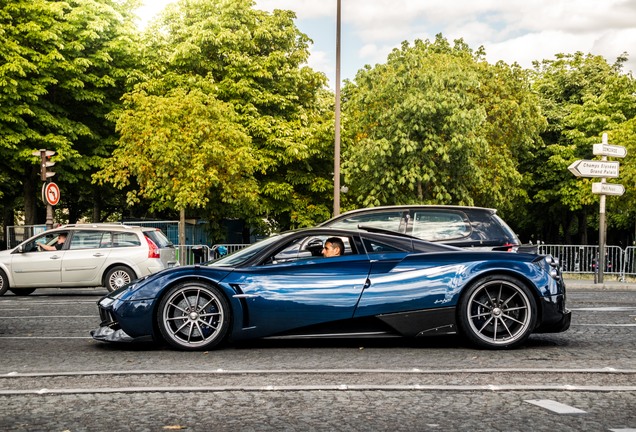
[{"x1": 0, "y1": 224, "x2": 177, "y2": 295}]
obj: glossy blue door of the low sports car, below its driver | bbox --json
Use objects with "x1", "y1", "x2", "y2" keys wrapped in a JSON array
[{"x1": 223, "y1": 236, "x2": 370, "y2": 337}]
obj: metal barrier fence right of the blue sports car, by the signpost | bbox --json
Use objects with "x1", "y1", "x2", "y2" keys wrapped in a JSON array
[{"x1": 538, "y1": 244, "x2": 636, "y2": 280}]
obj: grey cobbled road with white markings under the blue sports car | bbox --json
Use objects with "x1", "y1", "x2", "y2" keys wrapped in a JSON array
[{"x1": 0, "y1": 285, "x2": 636, "y2": 432}]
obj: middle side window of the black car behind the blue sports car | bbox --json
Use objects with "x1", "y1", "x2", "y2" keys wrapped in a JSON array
[{"x1": 411, "y1": 210, "x2": 471, "y2": 241}]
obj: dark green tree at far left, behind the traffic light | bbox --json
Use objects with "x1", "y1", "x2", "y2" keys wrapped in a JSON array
[{"x1": 0, "y1": 0, "x2": 139, "y2": 230}]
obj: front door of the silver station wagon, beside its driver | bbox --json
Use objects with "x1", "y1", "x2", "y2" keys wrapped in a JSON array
[{"x1": 11, "y1": 233, "x2": 66, "y2": 287}]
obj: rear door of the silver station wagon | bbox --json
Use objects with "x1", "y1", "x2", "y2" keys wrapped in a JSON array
[{"x1": 62, "y1": 230, "x2": 112, "y2": 286}]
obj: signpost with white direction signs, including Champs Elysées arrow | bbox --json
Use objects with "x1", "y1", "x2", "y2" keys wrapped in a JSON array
[{"x1": 568, "y1": 133, "x2": 627, "y2": 283}]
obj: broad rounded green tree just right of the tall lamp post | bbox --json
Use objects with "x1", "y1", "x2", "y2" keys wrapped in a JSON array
[{"x1": 343, "y1": 35, "x2": 543, "y2": 219}]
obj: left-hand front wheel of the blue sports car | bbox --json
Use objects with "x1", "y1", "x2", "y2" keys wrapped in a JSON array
[{"x1": 156, "y1": 282, "x2": 230, "y2": 351}]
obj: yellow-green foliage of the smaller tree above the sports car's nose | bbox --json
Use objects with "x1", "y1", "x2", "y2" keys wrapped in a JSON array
[{"x1": 96, "y1": 80, "x2": 255, "y2": 210}]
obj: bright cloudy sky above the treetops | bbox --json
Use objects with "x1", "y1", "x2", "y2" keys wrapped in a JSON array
[{"x1": 138, "y1": 0, "x2": 636, "y2": 88}]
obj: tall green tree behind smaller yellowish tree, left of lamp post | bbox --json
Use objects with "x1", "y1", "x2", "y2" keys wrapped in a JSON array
[{"x1": 101, "y1": 0, "x2": 333, "y2": 238}]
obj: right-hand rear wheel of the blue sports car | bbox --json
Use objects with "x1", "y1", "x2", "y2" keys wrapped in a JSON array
[{"x1": 458, "y1": 275, "x2": 537, "y2": 349}]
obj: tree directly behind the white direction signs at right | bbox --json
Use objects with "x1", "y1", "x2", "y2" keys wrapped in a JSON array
[{"x1": 523, "y1": 52, "x2": 636, "y2": 244}]
